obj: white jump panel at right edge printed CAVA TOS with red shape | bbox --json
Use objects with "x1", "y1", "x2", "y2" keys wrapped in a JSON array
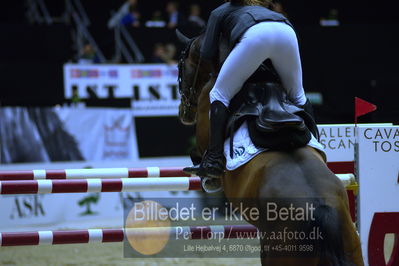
[{"x1": 356, "y1": 127, "x2": 399, "y2": 266}]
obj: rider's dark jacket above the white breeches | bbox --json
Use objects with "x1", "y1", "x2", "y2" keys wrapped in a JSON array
[{"x1": 201, "y1": 3, "x2": 292, "y2": 59}]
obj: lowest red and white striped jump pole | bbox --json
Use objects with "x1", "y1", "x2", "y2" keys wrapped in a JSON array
[{"x1": 0, "y1": 225, "x2": 258, "y2": 246}]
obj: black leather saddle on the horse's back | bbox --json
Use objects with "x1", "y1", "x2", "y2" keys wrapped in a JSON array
[{"x1": 226, "y1": 59, "x2": 319, "y2": 157}]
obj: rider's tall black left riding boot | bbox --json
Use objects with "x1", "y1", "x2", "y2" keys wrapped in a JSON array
[{"x1": 183, "y1": 101, "x2": 228, "y2": 178}]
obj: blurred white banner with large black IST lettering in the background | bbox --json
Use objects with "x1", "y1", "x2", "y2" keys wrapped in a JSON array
[{"x1": 64, "y1": 64, "x2": 180, "y2": 115}]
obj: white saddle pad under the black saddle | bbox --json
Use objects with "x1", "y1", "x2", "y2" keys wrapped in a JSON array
[{"x1": 224, "y1": 122, "x2": 324, "y2": 171}]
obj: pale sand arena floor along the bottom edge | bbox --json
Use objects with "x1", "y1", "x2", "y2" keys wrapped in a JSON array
[{"x1": 0, "y1": 234, "x2": 393, "y2": 266}]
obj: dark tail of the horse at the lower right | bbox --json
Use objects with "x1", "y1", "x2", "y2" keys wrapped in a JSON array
[{"x1": 313, "y1": 204, "x2": 353, "y2": 266}]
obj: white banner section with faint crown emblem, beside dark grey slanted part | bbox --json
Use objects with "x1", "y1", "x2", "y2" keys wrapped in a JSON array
[{"x1": 55, "y1": 108, "x2": 137, "y2": 161}]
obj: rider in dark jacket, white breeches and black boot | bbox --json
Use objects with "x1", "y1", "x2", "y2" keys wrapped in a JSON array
[{"x1": 185, "y1": 0, "x2": 307, "y2": 177}]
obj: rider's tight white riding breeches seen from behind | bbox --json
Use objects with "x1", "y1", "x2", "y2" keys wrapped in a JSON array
[{"x1": 210, "y1": 21, "x2": 306, "y2": 106}]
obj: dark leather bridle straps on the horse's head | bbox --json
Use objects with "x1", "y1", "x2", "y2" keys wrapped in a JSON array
[{"x1": 178, "y1": 38, "x2": 201, "y2": 115}]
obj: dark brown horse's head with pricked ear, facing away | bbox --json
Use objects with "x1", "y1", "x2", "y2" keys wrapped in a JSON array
[{"x1": 176, "y1": 30, "x2": 211, "y2": 125}]
